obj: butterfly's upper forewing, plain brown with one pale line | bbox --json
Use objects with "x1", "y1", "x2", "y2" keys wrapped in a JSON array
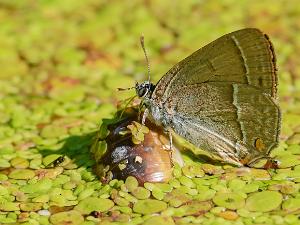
[{"x1": 152, "y1": 28, "x2": 277, "y2": 103}]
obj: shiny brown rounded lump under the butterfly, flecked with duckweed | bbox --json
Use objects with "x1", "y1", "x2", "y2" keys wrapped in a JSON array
[{"x1": 92, "y1": 108, "x2": 183, "y2": 184}]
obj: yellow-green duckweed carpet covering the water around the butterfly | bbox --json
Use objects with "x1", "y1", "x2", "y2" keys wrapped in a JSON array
[{"x1": 0, "y1": 0, "x2": 300, "y2": 225}]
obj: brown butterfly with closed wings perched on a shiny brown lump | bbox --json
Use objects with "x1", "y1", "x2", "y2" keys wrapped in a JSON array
[{"x1": 135, "y1": 28, "x2": 281, "y2": 166}]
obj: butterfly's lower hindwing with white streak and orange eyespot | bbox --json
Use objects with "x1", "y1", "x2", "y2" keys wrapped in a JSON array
[{"x1": 165, "y1": 82, "x2": 280, "y2": 164}]
